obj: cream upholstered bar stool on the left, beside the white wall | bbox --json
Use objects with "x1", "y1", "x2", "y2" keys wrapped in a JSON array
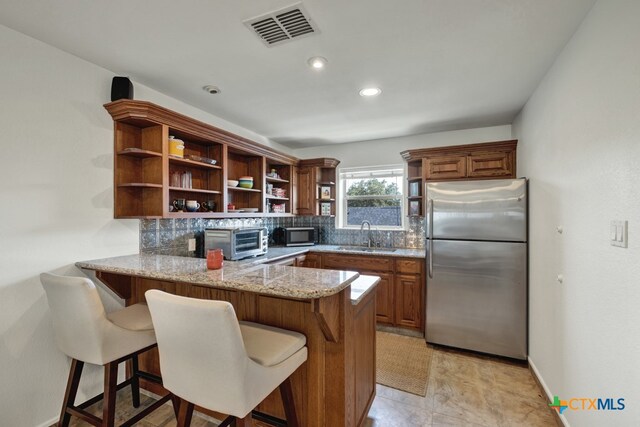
[{"x1": 40, "y1": 273, "x2": 171, "y2": 427}]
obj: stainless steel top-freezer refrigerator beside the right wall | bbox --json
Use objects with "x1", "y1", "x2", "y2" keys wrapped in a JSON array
[{"x1": 425, "y1": 179, "x2": 527, "y2": 359}]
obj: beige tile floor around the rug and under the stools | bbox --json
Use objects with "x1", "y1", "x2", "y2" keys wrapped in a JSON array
[{"x1": 62, "y1": 347, "x2": 556, "y2": 427}]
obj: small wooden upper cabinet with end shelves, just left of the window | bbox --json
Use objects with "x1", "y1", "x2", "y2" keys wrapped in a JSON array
[{"x1": 296, "y1": 158, "x2": 340, "y2": 216}]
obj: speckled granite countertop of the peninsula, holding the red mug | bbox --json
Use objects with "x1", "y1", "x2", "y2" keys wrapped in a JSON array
[{"x1": 76, "y1": 254, "x2": 359, "y2": 300}]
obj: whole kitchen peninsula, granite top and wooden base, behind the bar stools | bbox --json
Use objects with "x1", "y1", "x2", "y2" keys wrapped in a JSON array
[{"x1": 76, "y1": 255, "x2": 378, "y2": 426}]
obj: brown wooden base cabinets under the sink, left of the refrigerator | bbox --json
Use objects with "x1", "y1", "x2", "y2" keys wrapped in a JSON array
[{"x1": 318, "y1": 253, "x2": 425, "y2": 332}]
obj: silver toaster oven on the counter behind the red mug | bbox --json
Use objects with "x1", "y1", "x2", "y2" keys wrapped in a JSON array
[{"x1": 204, "y1": 227, "x2": 269, "y2": 261}]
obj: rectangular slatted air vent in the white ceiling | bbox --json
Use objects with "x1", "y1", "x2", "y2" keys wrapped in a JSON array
[{"x1": 244, "y1": 3, "x2": 319, "y2": 46}]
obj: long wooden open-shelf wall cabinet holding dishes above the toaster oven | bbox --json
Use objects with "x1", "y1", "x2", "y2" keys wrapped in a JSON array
[{"x1": 105, "y1": 100, "x2": 298, "y2": 218}]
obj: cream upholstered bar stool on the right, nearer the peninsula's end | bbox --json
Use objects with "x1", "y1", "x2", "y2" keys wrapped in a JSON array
[{"x1": 145, "y1": 290, "x2": 307, "y2": 427}]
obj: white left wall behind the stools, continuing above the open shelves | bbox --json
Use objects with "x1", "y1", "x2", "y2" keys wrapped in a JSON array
[{"x1": 0, "y1": 26, "x2": 285, "y2": 426}]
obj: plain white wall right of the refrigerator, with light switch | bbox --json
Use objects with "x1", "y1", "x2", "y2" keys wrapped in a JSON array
[{"x1": 514, "y1": 0, "x2": 640, "y2": 426}]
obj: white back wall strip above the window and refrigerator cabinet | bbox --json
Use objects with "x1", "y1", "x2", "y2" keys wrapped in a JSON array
[{"x1": 293, "y1": 125, "x2": 512, "y2": 168}]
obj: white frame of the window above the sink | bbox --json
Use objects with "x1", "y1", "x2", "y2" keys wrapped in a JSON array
[{"x1": 336, "y1": 164, "x2": 407, "y2": 231}]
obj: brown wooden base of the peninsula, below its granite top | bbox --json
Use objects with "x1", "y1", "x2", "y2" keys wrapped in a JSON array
[{"x1": 93, "y1": 267, "x2": 376, "y2": 427}]
